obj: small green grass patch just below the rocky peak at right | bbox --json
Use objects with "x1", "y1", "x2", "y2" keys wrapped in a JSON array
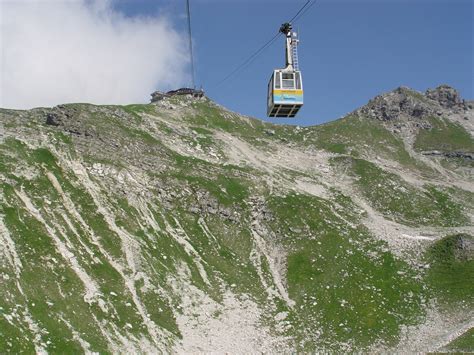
[{"x1": 414, "y1": 117, "x2": 474, "y2": 152}]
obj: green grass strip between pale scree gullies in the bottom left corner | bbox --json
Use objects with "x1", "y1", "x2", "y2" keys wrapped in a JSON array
[{"x1": 0, "y1": 200, "x2": 110, "y2": 352}]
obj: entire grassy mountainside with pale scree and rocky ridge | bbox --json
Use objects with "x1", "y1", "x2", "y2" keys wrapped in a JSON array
[{"x1": 0, "y1": 86, "x2": 474, "y2": 353}]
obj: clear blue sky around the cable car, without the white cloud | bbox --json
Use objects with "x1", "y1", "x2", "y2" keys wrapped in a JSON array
[{"x1": 118, "y1": 0, "x2": 474, "y2": 125}]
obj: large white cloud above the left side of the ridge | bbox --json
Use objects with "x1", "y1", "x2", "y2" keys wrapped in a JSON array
[{"x1": 0, "y1": 0, "x2": 188, "y2": 108}]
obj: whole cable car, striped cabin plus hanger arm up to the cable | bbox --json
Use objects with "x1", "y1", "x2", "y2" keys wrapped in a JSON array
[{"x1": 267, "y1": 23, "x2": 303, "y2": 117}]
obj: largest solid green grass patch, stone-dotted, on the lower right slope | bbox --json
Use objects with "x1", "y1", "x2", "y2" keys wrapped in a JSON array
[{"x1": 270, "y1": 194, "x2": 423, "y2": 351}]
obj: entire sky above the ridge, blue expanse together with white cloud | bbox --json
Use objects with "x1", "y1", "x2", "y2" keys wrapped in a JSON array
[{"x1": 0, "y1": 0, "x2": 474, "y2": 125}]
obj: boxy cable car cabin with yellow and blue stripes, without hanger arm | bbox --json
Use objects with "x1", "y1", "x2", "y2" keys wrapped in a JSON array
[{"x1": 267, "y1": 69, "x2": 303, "y2": 117}]
